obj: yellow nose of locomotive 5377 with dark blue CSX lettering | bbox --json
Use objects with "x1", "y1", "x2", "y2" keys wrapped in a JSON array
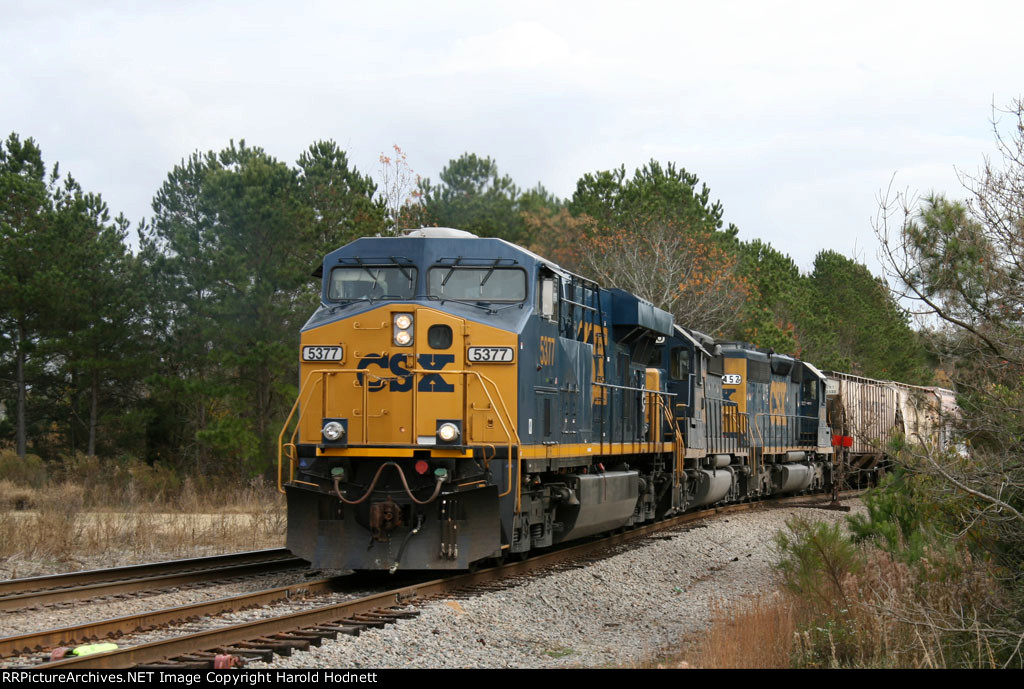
[{"x1": 298, "y1": 304, "x2": 517, "y2": 448}]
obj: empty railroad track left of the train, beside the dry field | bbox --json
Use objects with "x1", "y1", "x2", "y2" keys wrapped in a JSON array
[{"x1": 0, "y1": 548, "x2": 307, "y2": 610}]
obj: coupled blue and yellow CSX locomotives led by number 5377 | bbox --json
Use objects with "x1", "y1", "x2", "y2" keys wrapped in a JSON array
[{"x1": 279, "y1": 228, "x2": 946, "y2": 572}]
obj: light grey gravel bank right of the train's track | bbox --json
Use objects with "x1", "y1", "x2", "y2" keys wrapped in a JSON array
[{"x1": 248, "y1": 501, "x2": 863, "y2": 669}]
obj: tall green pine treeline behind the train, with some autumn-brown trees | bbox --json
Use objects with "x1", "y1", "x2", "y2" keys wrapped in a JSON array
[{"x1": 0, "y1": 134, "x2": 931, "y2": 477}]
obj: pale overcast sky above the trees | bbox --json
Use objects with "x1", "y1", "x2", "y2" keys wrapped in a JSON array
[{"x1": 0, "y1": 0, "x2": 1024, "y2": 271}]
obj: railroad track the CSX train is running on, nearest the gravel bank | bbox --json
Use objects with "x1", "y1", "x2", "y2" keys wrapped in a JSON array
[{"x1": 0, "y1": 491, "x2": 859, "y2": 670}]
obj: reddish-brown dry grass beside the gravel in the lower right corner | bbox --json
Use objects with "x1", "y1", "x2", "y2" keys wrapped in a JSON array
[{"x1": 663, "y1": 549, "x2": 998, "y2": 669}]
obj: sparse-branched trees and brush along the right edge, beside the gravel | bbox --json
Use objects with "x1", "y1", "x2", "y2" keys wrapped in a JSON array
[{"x1": 742, "y1": 98, "x2": 1024, "y2": 669}]
